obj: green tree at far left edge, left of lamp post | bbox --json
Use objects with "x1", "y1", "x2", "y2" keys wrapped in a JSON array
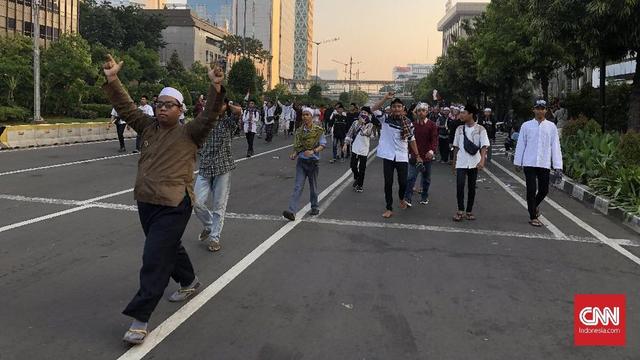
[{"x1": 0, "y1": 35, "x2": 33, "y2": 107}]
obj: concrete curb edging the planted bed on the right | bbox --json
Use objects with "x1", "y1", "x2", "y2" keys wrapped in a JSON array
[{"x1": 506, "y1": 152, "x2": 640, "y2": 234}]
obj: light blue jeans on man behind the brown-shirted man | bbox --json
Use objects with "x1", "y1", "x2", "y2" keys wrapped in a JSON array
[{"x1": 194, "y1": 173, "x2": 231, "y2": 242}]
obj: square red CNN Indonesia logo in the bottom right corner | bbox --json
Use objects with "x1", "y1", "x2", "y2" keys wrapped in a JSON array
[{"x1": 573, "y1": 294, "x2": 626, "y2": 346}]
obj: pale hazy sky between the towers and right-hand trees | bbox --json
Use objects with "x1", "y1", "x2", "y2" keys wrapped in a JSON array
[{"x1": 313, "y1": 0, "x2": 481, "y2": 80}]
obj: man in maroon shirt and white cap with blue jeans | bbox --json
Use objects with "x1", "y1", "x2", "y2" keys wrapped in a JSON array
[{"x1": 404, "y1": 103, "x2": 446, "y2": 207}]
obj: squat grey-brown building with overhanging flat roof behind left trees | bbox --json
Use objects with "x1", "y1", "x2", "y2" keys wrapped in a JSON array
[{"x1": 145, "y1": 9, "x2": 227, "y2": 68}]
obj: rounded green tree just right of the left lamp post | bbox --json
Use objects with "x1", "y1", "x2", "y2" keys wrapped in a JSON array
[{"x1": 42, "y1": 34, "x2": 97, "y2": 114}]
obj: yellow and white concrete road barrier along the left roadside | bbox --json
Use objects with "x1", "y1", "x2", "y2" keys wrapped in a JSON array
[{"x1": 0, "y1": 121, "x2": 136, "y2": 149}]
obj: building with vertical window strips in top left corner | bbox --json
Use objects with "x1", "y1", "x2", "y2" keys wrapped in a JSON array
[{"x1": 0, "y1": 0, "x2": 78, "y2": 46}]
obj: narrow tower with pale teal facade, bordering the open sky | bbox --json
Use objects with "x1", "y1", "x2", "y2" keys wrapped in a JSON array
[{"x1": 293, "y1": 0, "x2": 314, "y2": 80}]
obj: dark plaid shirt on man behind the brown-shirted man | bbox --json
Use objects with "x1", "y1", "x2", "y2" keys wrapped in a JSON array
[{"x1": 198, "y1": 115, "x2": 236, "y2": 178}]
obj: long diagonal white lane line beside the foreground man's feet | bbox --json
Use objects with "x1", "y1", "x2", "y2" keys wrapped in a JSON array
[{"x1": 118, "y1": 161, "x2": 351, "y2": 360}]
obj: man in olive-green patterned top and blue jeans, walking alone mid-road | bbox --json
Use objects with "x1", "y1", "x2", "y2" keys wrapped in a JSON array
[{"x1": 282, "y1": 107, "x2": 327, "y2": 221}]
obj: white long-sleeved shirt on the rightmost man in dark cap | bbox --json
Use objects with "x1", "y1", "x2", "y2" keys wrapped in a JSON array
[{"x1": 513, "y1": 119, "x2": 562, "y2": 170}]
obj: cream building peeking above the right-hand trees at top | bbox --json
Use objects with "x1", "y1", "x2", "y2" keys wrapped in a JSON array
[{"x1": 438, "y1": 0, "x2": 489, "y2": 55}]
